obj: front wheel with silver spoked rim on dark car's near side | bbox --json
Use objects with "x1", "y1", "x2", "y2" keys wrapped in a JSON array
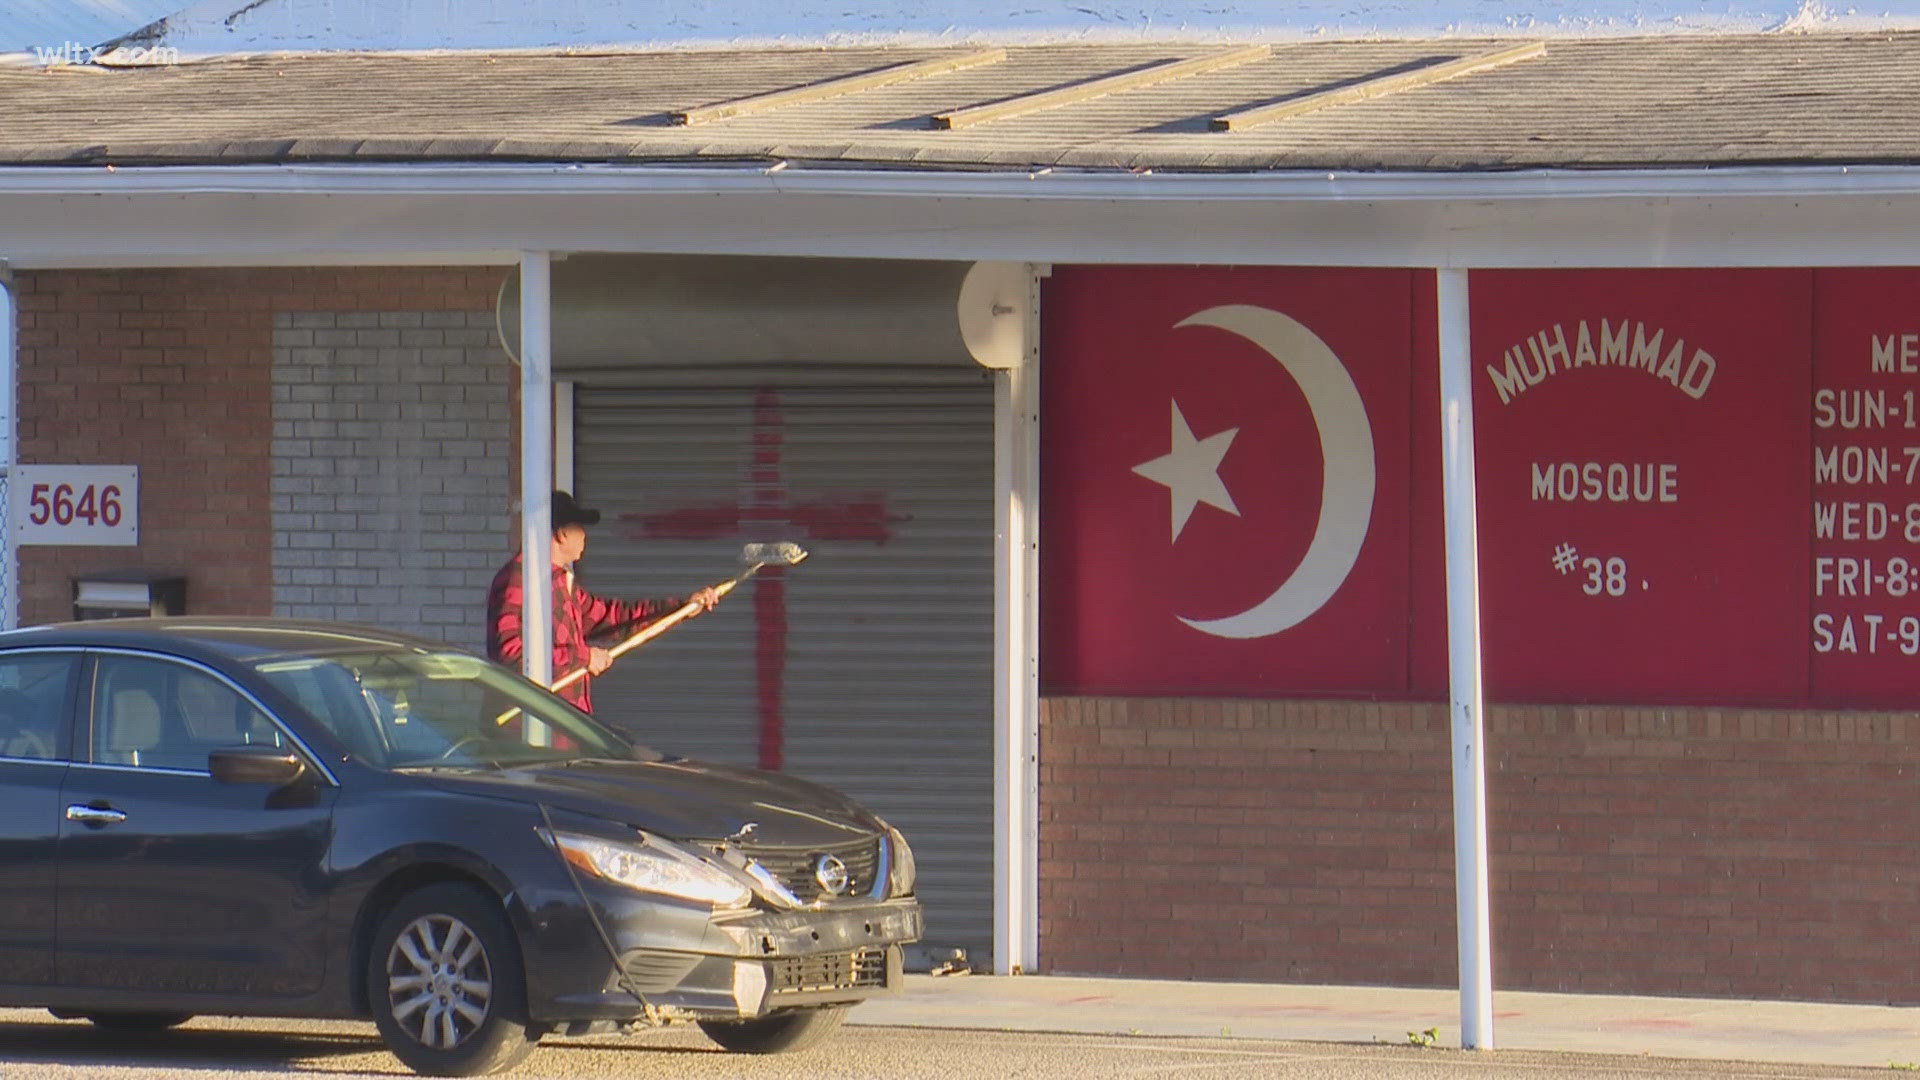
[{"x1": 367, "y1": 882, "x2": 540, "y2": 1076}]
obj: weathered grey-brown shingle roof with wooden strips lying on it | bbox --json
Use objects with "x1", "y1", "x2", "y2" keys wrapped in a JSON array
[{"x1": 0, "y1": 33, "x2": 1920, "y2": 171}]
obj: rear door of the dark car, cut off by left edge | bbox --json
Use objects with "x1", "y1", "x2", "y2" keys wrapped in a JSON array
[{"x1": 0, "y1": 650, "x2": 79, "y2": 986}]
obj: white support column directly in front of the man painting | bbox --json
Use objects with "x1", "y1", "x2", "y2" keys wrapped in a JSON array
[{"x1": 520, "y1": 252, "x2": 553, "y2": 686}]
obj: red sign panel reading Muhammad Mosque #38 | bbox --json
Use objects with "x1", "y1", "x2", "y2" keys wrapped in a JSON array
[{"x1": 1471, "y1": 269, "x2": 1812, "y2": 703}]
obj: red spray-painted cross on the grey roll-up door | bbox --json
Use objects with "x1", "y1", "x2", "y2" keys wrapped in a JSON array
[{"x1": 622, "y1": 388, "x2": 904, "y2": 769}]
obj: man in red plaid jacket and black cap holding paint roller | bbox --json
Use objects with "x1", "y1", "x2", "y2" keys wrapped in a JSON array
[{"x1": 486, "y1": 492, "x2": 720, "y2": 713}]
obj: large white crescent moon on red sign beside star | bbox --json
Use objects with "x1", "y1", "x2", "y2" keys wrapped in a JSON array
[{"x1": 1175, "y1": 304, "x2": 1375, "y2": 638}]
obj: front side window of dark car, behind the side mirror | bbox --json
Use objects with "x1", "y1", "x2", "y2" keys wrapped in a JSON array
[{"x1": 92, "y1": 655, "x2": 286, "y2": 773}]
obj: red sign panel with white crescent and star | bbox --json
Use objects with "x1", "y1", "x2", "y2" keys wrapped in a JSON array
[{"x1": 1041, "y1": 267, "x2": 1430, "y2": 694}]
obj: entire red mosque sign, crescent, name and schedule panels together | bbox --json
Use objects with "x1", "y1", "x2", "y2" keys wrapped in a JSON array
[{"x1": 1041, "y1": 267, "x2": 1920, "y2": 707}]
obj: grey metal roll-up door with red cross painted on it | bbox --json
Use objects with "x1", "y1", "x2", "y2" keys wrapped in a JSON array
[{"x1": 574, "y1": 367, "x2": 995, "y2": 963}]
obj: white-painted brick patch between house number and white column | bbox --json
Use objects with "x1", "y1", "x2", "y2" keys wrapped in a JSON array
[{"x1": 271, "y1": 311, "x2": 518, "y2": 648}]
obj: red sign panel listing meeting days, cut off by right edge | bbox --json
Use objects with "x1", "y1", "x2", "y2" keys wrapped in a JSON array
[{"x1": 1811, "y1": 269, "x2": 1920, "y2": 709}]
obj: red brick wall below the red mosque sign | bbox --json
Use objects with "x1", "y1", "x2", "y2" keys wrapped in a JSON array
[{"x1": 1041, "y1": 698, "x2": 1920, "y2": 1001}]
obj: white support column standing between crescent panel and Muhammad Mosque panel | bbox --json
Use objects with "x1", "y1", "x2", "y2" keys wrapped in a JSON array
[{"x1": 1438, "y1": 269, "x2": 1494, "y2": 1049}]
